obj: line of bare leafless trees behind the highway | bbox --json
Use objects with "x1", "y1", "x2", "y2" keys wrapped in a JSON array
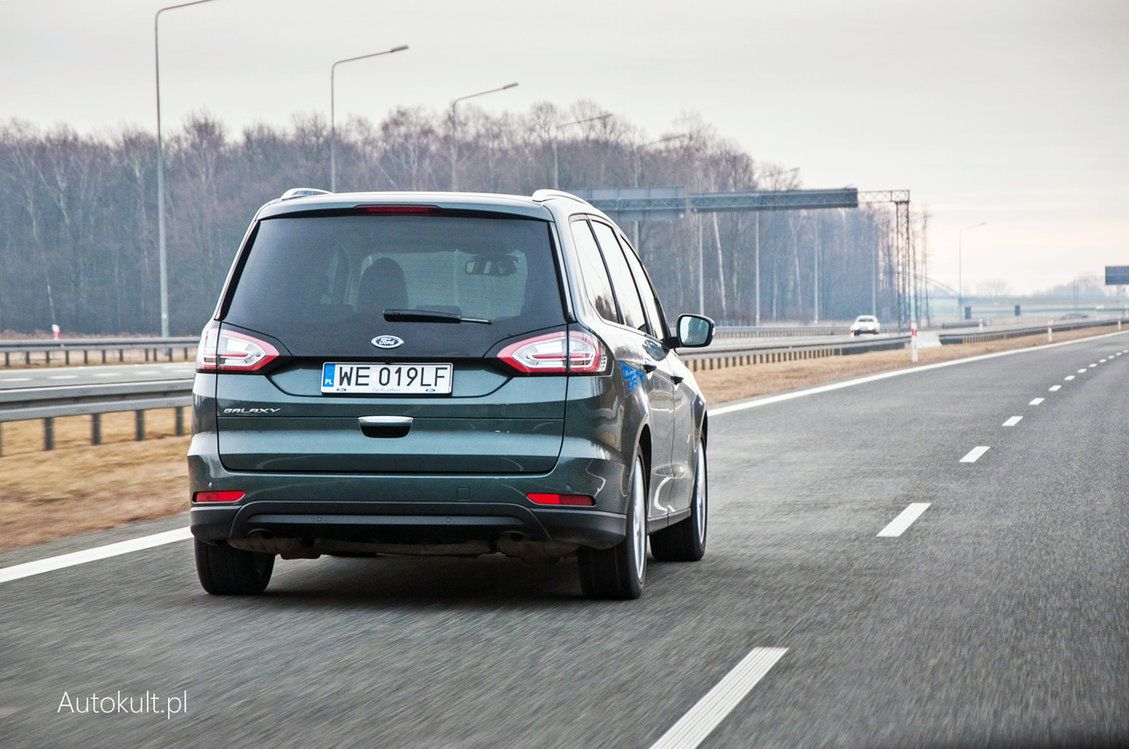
[{"x1": 0, "y1": 102, "x2": 921, "y2": 334}]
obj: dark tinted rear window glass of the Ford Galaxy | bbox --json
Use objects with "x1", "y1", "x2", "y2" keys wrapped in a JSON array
[{"x1": 225, "y1": 214, "x2": 563, "y2": 355}]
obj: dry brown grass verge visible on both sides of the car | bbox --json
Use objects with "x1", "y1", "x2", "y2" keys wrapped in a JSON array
[{"x1": 0, "y1": 330, "x2": 1108, "y2": 550}]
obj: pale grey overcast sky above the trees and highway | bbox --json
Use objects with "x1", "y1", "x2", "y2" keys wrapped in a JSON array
[{"x1": 0, "y1": 0, "x2": 1129, "y2": 291}]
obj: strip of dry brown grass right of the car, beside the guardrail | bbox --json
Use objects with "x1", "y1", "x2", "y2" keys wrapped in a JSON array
[{"x1": 694, "y1": 329, "x2": 1110, "y2": 404}]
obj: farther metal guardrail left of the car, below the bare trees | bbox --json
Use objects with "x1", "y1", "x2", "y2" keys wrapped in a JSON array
[{"x1": 0, "y1": 336, "x2": 200, "y2": 367}]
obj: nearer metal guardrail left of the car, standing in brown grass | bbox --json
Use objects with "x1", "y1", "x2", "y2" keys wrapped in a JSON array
[{"x1": 0, "y1": 380, "x2": 192, "y2": 454}]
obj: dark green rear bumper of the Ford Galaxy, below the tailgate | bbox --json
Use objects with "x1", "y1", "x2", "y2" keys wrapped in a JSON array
[{"x1": 189, "y1": 433, "x2": 628, "y2": 549}]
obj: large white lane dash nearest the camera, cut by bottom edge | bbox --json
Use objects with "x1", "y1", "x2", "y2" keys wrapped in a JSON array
[{"x1": 650, "y1": 647, "x2": 788, "y2": 749}]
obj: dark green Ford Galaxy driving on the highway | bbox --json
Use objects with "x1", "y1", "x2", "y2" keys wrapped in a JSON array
[{"x1": 189, "y1": 190, "x2": 714, "y2": 598}]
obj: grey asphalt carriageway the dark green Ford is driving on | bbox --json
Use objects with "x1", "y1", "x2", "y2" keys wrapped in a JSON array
[{"x1": 0, "y1": 332, "x2": 1129, "y2": 747}]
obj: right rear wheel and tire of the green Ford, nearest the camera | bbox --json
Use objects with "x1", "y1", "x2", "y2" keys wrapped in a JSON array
[{"x1": 577, "y1": 458, "x2": 647, "y2": 599}]
